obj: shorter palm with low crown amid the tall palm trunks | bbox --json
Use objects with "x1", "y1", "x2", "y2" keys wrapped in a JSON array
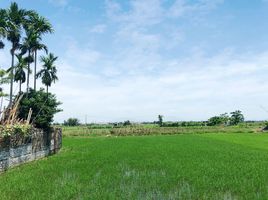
[{"x1": 7, "y1": 54, "x2": 28, "y2": 93}]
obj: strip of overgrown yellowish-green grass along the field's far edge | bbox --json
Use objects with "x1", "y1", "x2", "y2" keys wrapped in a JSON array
[{"x1": 59, "y1": 123, "x2": 265, "y2": 136}]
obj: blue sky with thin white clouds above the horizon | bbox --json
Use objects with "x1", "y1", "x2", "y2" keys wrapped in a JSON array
[{"x1": 0, "y1": 0, "x2": 268, "y2": 123}]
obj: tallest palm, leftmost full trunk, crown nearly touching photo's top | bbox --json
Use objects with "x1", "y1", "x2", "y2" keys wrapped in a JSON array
[{"x1": 0, "y1": 2, "x2": 33, "y2": 105}]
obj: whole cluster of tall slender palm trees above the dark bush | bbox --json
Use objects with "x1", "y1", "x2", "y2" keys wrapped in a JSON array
[{"x1": 0, "y1": 2, "x2": 58, "y2": 105}]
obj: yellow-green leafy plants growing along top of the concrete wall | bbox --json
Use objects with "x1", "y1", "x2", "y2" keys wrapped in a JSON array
[{"x1": 0, "y1": 124, "x2": 31, "y2": 137}]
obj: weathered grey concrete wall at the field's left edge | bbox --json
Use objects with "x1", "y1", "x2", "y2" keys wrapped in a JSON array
[{"x1": 0, "y1": 128, "x2": 62, "y2": 172}]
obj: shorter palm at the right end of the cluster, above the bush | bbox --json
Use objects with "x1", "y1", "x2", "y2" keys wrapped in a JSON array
[{"x1": 36, "y1": 53, "x2": 58, "y2": 94}]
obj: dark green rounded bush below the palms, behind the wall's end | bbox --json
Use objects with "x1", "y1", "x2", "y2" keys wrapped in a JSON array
[{"x1": 18, "y1": 89, "x2": 61, "y2": 129}]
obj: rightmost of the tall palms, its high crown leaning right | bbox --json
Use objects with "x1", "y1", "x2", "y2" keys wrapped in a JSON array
[{"x1": 28, "y1": 13, "x2": 54, "y2": 90}]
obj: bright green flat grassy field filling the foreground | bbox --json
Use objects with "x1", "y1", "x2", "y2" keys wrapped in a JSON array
[{"x1": 0, "y1": 134, "x2": 268, "y2": 200}]
